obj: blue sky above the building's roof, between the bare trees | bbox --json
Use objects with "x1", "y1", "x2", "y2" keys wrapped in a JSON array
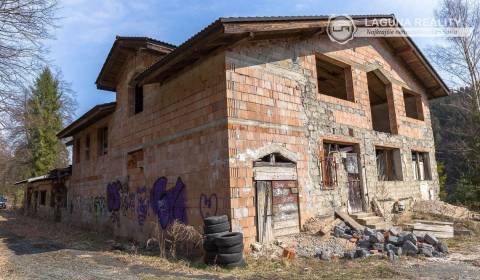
[{"x1": 47, "y1": 0, "x2": 439, "y2": 117}]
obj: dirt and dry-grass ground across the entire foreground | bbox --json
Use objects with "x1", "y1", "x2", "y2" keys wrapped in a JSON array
[{"x1": 0, "y1": 211, "x2": 480, "y2": 279}]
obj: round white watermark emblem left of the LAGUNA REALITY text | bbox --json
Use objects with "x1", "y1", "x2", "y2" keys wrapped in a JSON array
[{"x1": 327, "y1": 16, "x2": 357, "y2": 44}]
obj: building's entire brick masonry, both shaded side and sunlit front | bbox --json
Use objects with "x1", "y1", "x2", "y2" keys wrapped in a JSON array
[{"x1": 25, "y1": 33, "x2": 438, "y2": 249}]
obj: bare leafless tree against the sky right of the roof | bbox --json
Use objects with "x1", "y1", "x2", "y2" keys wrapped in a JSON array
[{"x1": 429, "y1": 0, "x2": 480, "y2": 112}]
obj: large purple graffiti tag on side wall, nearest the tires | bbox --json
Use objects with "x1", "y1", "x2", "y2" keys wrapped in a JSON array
[{"x1": 150, "y1": 177, "x2": 187, "y2": 229}]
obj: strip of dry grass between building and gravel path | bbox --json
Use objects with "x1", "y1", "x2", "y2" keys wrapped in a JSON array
[{"x1": 0, "y1": 210, "x2": 480, "y2": 280}]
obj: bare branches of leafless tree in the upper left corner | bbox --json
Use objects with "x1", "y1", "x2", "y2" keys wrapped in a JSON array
[{"x1": 0, "y1": 0, "x2": 57, "y2": 127}]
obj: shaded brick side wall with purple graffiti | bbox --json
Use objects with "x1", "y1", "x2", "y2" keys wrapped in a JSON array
[{"x1": 70, "y1": 50, "x2": 230, "y2": 240}]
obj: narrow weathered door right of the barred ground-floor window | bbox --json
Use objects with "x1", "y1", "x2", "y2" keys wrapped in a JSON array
[{"x1": 346, "y1": 153, "x2": 363, "y2": 213}]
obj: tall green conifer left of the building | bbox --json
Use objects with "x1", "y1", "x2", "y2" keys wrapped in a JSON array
[{"x1": 26, "y1": 67, "x2": 65, "y2": 176}]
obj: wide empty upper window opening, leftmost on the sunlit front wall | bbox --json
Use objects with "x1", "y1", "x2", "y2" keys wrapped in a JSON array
[{"x1": 316, "y1": 55, "x2": 354, "y2": 101}]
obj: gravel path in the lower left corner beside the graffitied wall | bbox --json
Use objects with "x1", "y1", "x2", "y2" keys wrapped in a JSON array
[{"x1": 0, "y1": 211, "x2": 225, "y2": 280}]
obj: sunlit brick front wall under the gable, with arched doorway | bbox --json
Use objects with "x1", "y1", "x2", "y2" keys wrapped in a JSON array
[{"x1": 226, "y1": 36, "x2": 438, "y2": 247}]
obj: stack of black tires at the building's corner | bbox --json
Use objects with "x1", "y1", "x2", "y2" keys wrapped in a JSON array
[{"x1": 203, "y1": 215, "x2": 245, "y2": 268}]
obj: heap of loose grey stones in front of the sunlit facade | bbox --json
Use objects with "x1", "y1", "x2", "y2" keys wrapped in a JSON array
[{"x1": 316, "y1": 223, "x2": 448, "y2": 260}]
